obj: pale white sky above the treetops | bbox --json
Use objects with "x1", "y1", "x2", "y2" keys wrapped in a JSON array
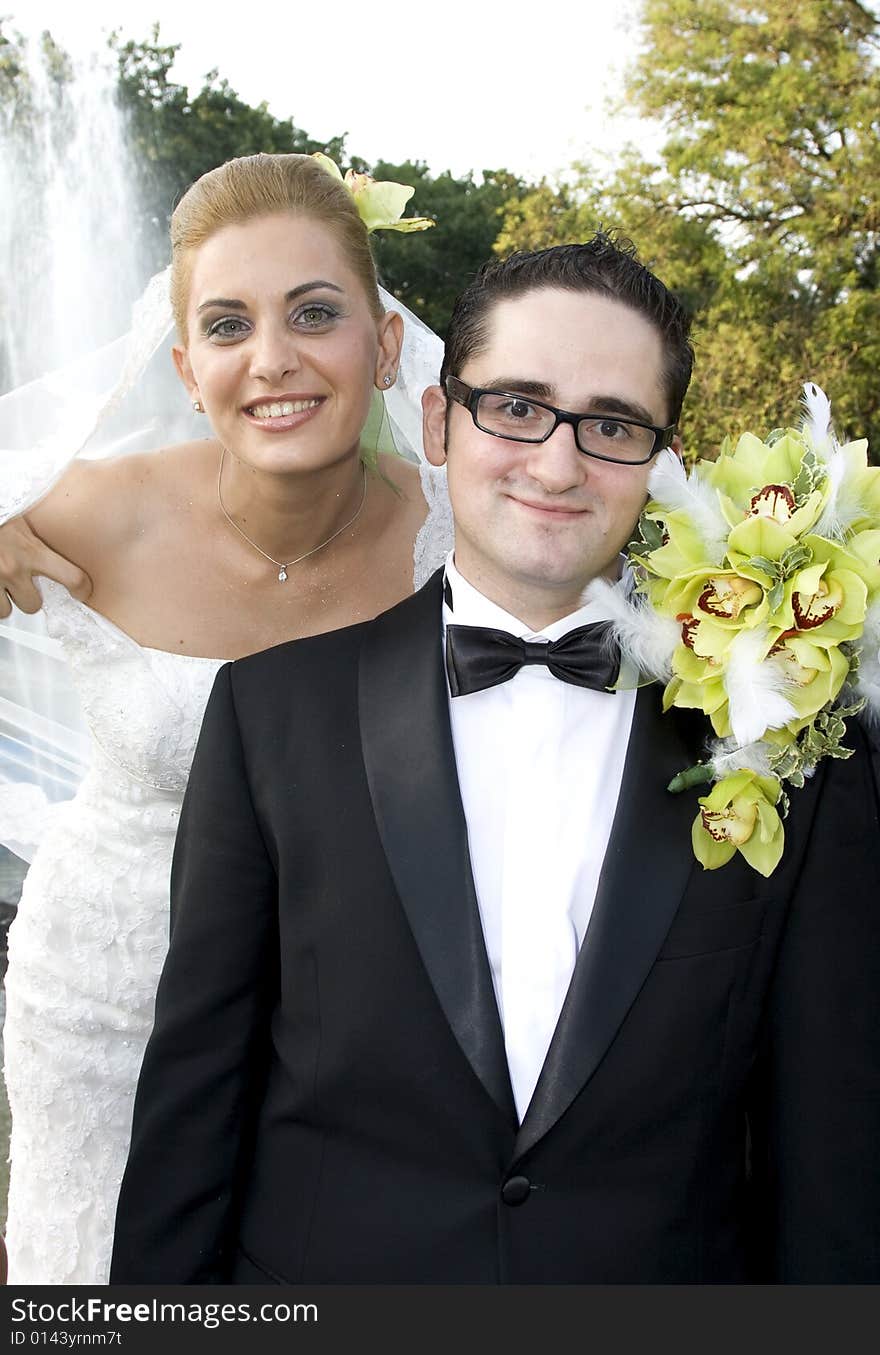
[{"x1": 15, "y1": 0, "x2": 651, "y2": 179}]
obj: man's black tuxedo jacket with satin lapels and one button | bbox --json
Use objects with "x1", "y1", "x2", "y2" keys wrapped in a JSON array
[{"x1": 111, "y1": 576, "x2": 880, "y2": 1283}]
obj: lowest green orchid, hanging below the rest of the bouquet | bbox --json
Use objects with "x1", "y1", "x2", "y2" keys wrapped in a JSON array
[{"x1": 692, "y1": 770, "x2": 785, "y2": 877}]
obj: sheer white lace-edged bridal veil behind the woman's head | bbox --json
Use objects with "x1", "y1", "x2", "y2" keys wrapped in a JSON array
[{"x1": 0, "y1": 270, "x2": 442, "y2": 860}]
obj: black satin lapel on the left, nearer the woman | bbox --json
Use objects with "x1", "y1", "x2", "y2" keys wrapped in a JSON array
[{"x1": 359, "y1": 570, "x2": 517, "y2": 1125}]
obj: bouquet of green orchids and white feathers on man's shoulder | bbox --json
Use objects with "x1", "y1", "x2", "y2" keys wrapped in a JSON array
[{"x1": 599, "y1": 383, "x2": 880, "y2": 875}]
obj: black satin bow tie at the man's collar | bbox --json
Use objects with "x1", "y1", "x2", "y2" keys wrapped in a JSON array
[{"x1": 446, "y1": 621, "x2": 620, "y2": 696}]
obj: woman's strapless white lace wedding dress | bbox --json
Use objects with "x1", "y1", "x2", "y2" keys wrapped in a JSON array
[{"x1": 4, "y1": 465, "x2": 452, "y2": 1285}]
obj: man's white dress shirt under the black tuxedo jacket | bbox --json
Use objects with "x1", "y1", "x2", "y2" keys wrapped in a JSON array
[{"x1": 443, "y1": 553, "x2": 636, "y2": 1121}]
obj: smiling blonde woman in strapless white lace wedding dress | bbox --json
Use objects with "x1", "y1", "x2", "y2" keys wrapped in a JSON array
[{"x1": 4, "y1": 154, "x2": 450, "y2": 1285}]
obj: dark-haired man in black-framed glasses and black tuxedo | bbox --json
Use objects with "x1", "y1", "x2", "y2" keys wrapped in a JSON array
[{"x1": 111, "y1": 236, "x2": 880, "y2": 1285}]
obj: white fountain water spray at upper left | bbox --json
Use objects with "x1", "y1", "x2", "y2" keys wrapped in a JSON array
[{"x1": 0, "y1": 29, "x2": 145, "y2": 390}]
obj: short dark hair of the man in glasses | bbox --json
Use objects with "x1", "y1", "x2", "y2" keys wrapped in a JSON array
[{"x1": 441, "y1": 230, "x2": 694, "y2": 423}]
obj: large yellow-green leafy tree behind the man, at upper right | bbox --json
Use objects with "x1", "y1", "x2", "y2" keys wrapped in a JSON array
[{"x1": 499, "y1": 0, "x2": 880, "y2": 455}]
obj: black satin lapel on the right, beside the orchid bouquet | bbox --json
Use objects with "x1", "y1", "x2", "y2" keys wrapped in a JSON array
[{"x1": 517, "y1": 687, "x2": 698, "y2": 1156}]
